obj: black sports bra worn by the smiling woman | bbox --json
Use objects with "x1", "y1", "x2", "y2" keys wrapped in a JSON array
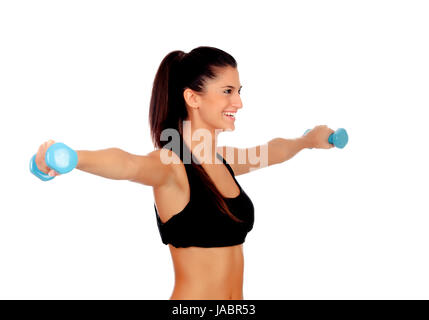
[{"x1": 154, "y1": 139, "x2": 254, "y2": 248}]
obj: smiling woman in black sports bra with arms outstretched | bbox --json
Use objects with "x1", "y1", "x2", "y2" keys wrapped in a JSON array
[{"x1": 36, "y1": 47, "x2": 334, "y2": 300}]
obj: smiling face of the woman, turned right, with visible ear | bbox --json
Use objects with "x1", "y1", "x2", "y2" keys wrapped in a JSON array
[{"x1": 184, "y1": 67, "x2": 243, "y2": 131}]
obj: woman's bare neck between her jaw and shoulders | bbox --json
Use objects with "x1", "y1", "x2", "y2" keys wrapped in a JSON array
[{"x1": 183, "y1": 121, "x2": 221, "y2": 164}]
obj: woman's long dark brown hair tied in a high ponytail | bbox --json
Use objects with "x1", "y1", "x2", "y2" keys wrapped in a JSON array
[{"x1": 149, "y1": 47, "x2": 243, "y2": 222}]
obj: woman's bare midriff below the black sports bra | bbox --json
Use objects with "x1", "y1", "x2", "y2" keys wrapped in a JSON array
[{"x1": 169, "y1": 245, "x2": 244, "y2": 300}]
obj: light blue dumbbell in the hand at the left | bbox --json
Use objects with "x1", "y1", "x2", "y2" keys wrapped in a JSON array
[{"x1": 30, "y1": 142, "x2": 77, "y2": 181}]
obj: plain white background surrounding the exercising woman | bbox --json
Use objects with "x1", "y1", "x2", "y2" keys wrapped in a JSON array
[{"x1": 0, "y1": 0, "x2": 429, "y2": 299}]
